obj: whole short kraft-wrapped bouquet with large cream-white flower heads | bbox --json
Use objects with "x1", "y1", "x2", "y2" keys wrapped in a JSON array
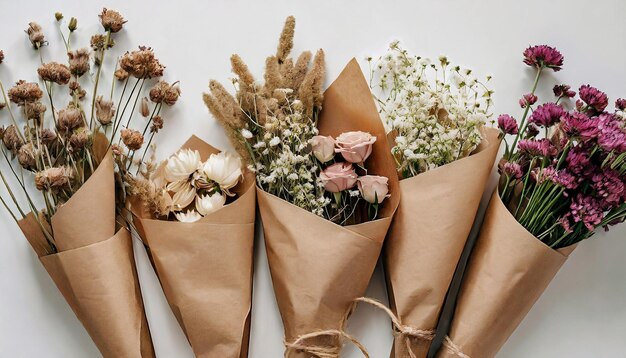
[{"x1": 131, "y1": 136, "x2": 256, "y2": 358}]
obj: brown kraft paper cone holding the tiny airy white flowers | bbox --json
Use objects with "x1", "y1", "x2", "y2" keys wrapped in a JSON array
[{"x1": 383, "y1": 128, "x2": 500, "y2": 357}]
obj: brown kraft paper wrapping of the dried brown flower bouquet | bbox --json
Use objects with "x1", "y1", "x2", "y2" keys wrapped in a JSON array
[{"x1": 19, "y1": 137, "x2": 155, "y2": 358}]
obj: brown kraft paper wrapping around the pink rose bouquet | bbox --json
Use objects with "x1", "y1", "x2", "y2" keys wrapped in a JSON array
[{"x1": 257, "y1": 59, "x2": 400, "y2": 357}]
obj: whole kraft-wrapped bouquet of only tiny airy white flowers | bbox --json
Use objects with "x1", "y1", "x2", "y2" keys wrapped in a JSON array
[{"x1": 364, "y1": 42, "x2": 501, "y2": 357}]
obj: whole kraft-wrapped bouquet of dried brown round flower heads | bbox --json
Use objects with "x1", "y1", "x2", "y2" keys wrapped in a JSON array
[{"x1": 0, "y1": 9, "x2": 180, "y2": 357}]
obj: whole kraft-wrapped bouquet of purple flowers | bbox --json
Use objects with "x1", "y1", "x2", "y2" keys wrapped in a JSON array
[{"x1": 438, "y1": 45, "x2": 626, "y2": 358}]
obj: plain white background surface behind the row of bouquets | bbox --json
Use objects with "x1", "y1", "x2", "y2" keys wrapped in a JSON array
[{"x1": 0, "y1": 0, "x2": 626, "y2": 358}]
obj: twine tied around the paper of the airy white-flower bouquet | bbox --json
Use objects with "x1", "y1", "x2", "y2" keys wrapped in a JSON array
[{"x1": 354, "y1": 297, "x2": 470, "y2": 358}]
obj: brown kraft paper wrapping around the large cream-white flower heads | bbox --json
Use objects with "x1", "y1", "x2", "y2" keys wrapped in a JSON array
[{"x1": 135, "y1": 136, "x2": 256, "y2": 358}]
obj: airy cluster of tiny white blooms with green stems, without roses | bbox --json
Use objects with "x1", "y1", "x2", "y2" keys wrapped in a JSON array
[{"x1": 368, "y1": 41, "x2": 493, "y2": 178}]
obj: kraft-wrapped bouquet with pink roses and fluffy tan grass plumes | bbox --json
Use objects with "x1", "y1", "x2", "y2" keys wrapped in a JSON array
[{"x1": 204, "y1": 17, "x2": 399, "y2": 357}]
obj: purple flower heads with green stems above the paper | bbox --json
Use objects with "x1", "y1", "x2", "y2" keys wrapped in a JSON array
[{"x1": 498, "y1": 46, "x2": 626, "y2": 248}]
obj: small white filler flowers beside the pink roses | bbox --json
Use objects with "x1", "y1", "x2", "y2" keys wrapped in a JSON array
[{"x1": 241, "y1": 94, "x2": 330, "y2": 216}]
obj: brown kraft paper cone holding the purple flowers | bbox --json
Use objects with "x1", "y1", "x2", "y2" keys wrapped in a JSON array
[{"x1": 437, "y1": 190, "x2": 575, "y2": 358}]
